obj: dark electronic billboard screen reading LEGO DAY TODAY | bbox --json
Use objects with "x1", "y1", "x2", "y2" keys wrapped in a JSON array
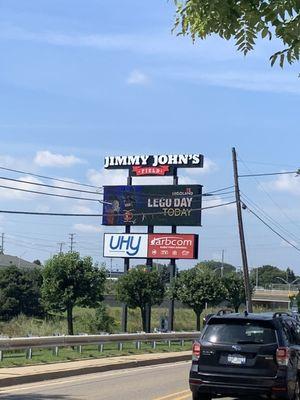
[{"x1": 102, "y1": 185, "x2": 202, "y2": 226}]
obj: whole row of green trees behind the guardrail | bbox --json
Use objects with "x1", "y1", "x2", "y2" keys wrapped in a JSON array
[{"x1": 0, "y1": 252, "x2": 297, "y2": 335}]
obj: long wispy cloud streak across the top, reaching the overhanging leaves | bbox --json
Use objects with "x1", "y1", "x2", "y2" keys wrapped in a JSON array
[{"x1": 0, "y1": 24, "x2": 240, "y2": 60}]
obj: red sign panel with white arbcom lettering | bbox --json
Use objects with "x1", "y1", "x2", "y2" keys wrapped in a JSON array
[{"x1": 148, "y1": 233, "x2": 198, "y2": 260}]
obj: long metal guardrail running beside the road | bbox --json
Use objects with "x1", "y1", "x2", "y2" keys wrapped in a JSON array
[{"x1": 0, "y1": 332, "x2": 200, "y2": 351}]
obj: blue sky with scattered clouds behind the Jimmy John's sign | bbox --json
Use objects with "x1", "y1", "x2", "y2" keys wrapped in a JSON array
[{"x1": 0, "y1": 0, "x2": 300, "y2": 273}]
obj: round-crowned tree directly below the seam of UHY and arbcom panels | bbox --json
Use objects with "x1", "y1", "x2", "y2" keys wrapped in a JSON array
[{"x1": 117, "y1": 266, "x2": 165, "y2": 331}]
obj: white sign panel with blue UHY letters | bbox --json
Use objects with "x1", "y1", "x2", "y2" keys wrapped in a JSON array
[{"x1": 104, "y1": 233, "x2": 147, "y2": 258}]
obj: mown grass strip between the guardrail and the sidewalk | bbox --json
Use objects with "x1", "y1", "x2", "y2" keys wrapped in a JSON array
[{"x1": 0, "y1": 341, "x2": 191, "y2": 368}]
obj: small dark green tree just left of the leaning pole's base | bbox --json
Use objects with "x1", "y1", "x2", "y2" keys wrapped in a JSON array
[{"x1": 223, "y1": 273, "x2": 246, "y2": 312}]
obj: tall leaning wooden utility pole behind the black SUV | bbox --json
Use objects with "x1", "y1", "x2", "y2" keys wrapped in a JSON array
[{"x1": 232, "y1": 147, "x2": 253, "y2": 312}]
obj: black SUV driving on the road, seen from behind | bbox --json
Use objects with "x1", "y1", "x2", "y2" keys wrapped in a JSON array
[{"x1": 189, "y1": 312, "x2": 300, "y2": 400}]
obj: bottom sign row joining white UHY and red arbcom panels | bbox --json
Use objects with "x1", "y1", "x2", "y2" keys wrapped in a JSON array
[{"x1": 103, "y1": 233, "x2": 198, "y2": 260}]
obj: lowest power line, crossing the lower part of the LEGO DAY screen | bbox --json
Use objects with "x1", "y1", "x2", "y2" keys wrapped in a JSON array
[{"x1": 0, "y1": 201, "x2": 235, "y2": 217}]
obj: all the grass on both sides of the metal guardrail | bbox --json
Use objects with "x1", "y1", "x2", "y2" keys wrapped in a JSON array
[{"x1": 0, "y1": 307, "x2": 284, "y2": 368}]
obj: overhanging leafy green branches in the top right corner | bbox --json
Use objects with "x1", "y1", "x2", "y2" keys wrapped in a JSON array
[{"x1": 174, "y1": 0, "x2": 300, "y2": 67}]
